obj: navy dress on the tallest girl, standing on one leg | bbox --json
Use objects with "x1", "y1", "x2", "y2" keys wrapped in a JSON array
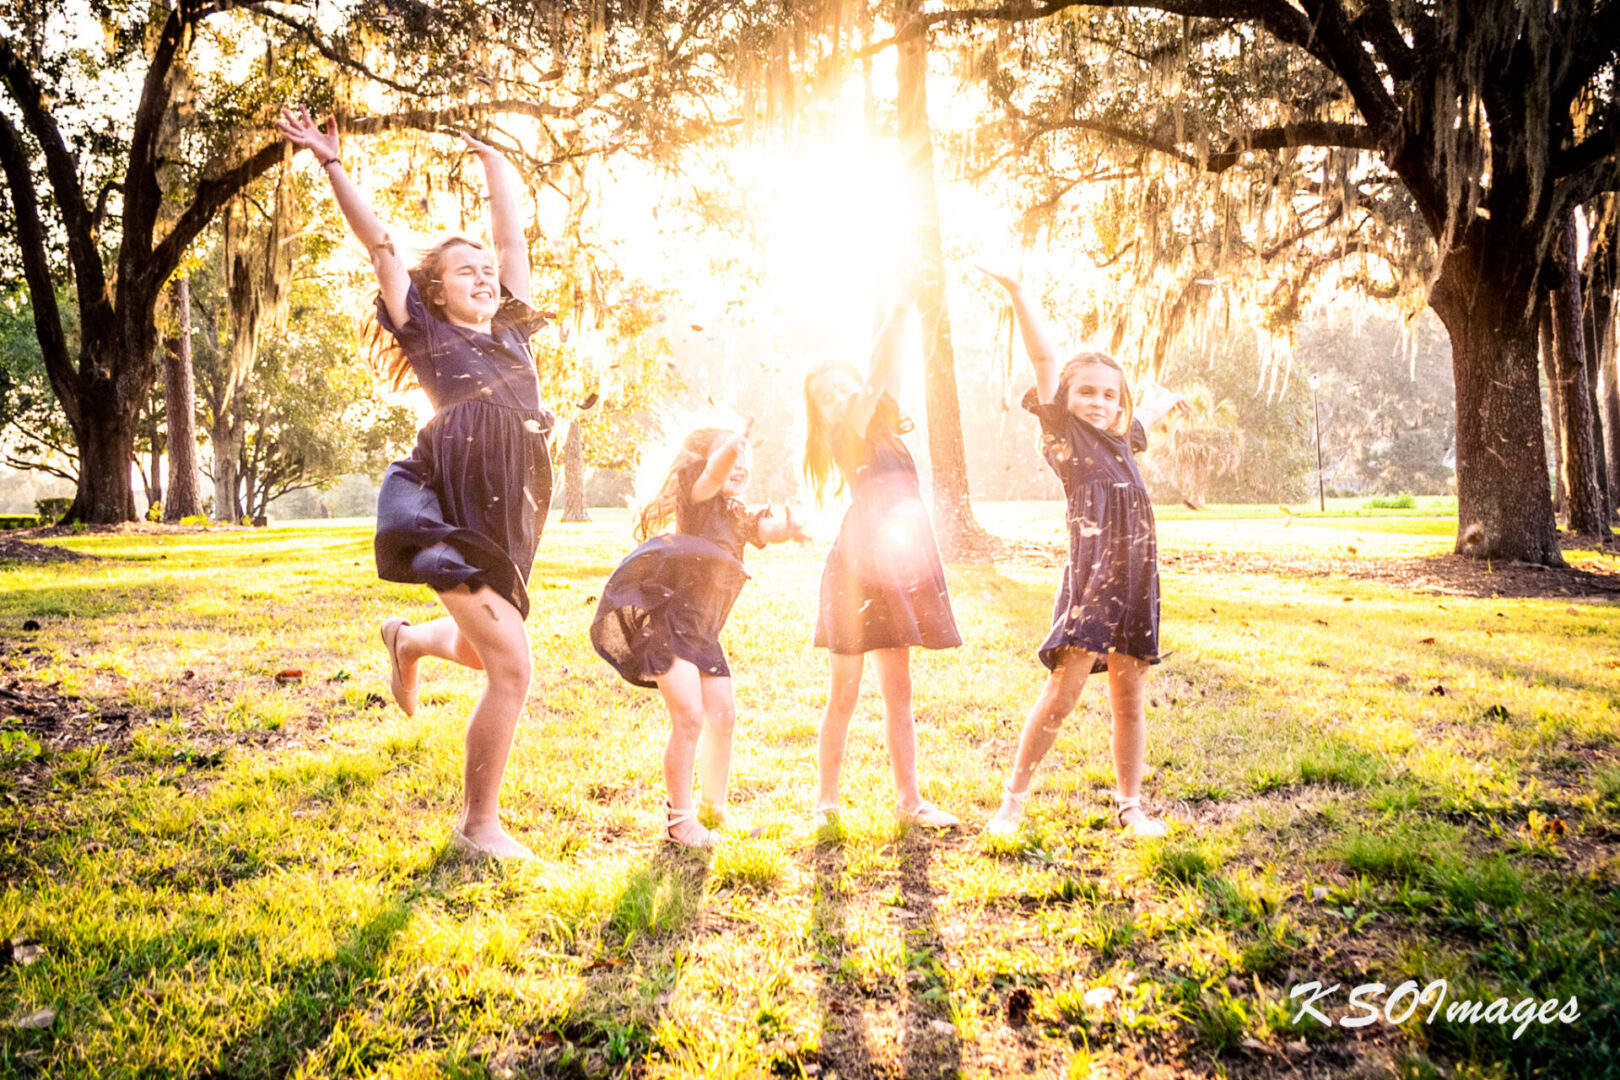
[{"x1": 374, "y1": 283, "x2": 554, "y2": 619}]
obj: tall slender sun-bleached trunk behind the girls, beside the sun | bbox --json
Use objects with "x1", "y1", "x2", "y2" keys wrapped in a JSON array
[{"x1": 894, "y1": 0, "x2": 990, "y2": 557}]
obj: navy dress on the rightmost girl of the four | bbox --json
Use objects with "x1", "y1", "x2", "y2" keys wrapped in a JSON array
[{"x1": 1024, "y1": 389, "x2": 1158, "y2": 674}]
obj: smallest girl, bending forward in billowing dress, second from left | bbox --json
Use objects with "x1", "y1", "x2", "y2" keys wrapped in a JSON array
[{"x1": 591, "y1": 421, "x2": 804, "y2": 848}]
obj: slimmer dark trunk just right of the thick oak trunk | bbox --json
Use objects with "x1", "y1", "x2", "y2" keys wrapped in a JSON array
[{"x1": 1552, "y1": 217, "x2": 1609, "y2": 536}]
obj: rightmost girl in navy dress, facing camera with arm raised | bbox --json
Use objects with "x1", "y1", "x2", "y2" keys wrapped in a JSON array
[{"x1": 985, "y1": 270, "x2": 1186, "y2": 836}]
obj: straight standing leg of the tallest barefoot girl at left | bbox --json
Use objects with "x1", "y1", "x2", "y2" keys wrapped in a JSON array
[{"x1": 428, "y1": 586, "x2": 533, "y2": 858}]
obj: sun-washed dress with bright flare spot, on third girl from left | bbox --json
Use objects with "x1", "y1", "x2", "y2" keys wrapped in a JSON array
[{"x1": 815, "y1": 395, "x2": 962, "y2": 656}]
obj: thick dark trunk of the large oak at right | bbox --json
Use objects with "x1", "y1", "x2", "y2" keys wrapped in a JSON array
[{"x1": 1429, "y1": 244, "x2": 1563, "y2": 567}]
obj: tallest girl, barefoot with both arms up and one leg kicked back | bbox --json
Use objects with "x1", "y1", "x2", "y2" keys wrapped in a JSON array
[{"x1": 277, "y1": 108, "x2": 552, "y2": 858}]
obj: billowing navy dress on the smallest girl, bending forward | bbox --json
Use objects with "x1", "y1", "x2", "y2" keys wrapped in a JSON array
[{"x1": 591, "y1": 461, "x2": 770, "y2": 688}]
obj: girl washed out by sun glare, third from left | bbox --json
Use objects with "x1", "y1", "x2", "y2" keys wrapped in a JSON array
[{"x1": 805, "y1": 301, "x2": 962, "y2": 829}]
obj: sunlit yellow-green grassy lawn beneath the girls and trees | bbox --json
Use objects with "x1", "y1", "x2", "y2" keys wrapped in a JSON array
[{"x1": 0, "y1": 500, "x2": 1620, "y2": 1080}]
